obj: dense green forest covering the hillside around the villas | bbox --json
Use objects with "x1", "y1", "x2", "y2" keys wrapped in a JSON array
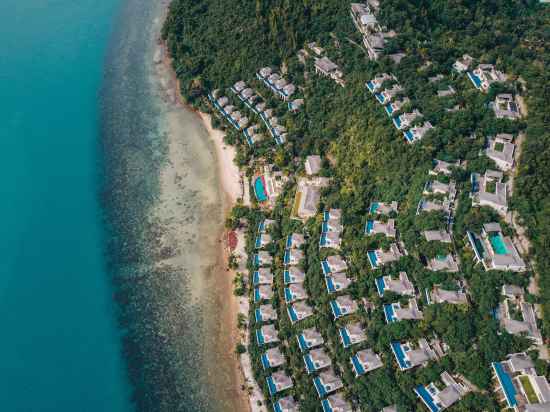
[{"x1": 163, "y1": 0, "x2": 550, "y2": 411}]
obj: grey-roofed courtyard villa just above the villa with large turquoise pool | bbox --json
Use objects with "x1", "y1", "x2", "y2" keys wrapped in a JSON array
[{"x1": 470, "y1": 170, "x2": 508, "y2": 216}]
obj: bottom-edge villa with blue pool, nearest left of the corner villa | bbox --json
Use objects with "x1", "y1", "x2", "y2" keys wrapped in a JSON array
[{"x1": 414, "y1": 372, "x2": 471, "y2": 412}]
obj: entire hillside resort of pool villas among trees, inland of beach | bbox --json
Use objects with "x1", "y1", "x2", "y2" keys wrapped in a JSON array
[{"x1": 165, "y1": 0, "x2": 550, "y2": 412}]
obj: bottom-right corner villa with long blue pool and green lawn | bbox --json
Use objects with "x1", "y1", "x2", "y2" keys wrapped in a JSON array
[{"x1": 491, "y1": 353, "x2": 550, "y2": 412}]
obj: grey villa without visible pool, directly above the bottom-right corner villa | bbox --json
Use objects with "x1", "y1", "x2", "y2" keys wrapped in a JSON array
[{"x1": 496, "y1": 285, "x2": 543, "y2": 345}]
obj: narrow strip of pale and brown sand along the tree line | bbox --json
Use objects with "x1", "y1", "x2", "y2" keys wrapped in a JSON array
[{"x1": 154, "y1": 28, "x2": 251, "y2": 411}]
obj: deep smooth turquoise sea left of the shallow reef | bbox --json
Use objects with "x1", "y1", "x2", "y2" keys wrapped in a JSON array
[{"x1": 0, "y1": 0, "x2": 134, "y2": 412}]
